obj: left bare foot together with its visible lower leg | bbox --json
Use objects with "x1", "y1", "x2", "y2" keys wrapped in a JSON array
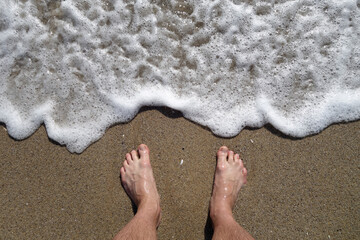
[{"x1": 114, "y1": 144, "x2": 161, "y2": 240}]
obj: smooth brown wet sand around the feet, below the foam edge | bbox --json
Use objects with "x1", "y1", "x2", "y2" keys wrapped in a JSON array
[{"x1": 0, "y1": 108, "x2": 360, "y2": 240}]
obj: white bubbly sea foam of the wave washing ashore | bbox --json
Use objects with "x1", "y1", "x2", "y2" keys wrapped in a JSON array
[{"x1": 0, "y1": 0, "x2": 360, "y2": 152}]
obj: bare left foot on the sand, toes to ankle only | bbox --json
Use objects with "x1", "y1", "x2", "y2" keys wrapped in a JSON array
[{"x1": 120, "y1": 144, "x2": 161, "y2": 226}]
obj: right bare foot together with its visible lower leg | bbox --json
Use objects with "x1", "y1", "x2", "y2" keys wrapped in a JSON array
[{"x1": 210, "y1": 147, "x2": 253, "y2": 240}]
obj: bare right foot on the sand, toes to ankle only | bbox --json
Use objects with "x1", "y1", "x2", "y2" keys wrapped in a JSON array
[{"x1": 210, "y1": 146, "x2": 247, "y2": 224}]
